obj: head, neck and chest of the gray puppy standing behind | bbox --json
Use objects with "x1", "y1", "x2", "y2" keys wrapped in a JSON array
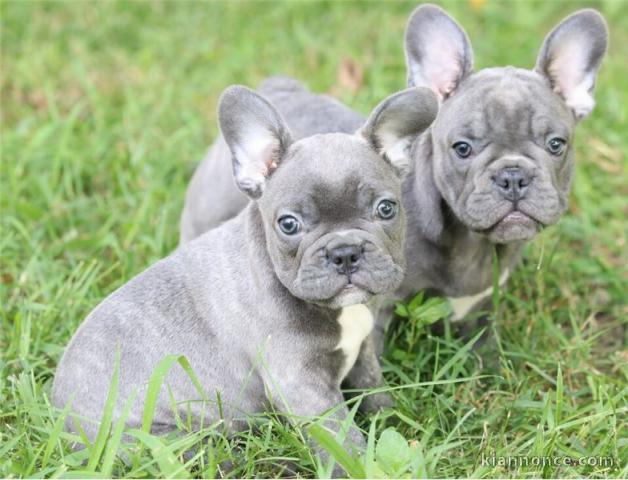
[{"x1": 397, "y1": 5, "x2": 608, "y2": 320}]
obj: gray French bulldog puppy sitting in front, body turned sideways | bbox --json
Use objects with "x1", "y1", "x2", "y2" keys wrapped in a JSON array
[{"x1": 52, "y1": 86, "x2": 438, "y2": 468}]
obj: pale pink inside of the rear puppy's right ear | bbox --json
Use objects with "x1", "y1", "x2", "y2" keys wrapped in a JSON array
[{"x1": 548, "y1": 35, "x2": 595, "y2": 118}]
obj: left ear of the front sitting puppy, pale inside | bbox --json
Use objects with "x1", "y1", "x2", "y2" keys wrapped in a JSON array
[{"x1": 218, "y1": 85, "x2": 292, "y2": 199}]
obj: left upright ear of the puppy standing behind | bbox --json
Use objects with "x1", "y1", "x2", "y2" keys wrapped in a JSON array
[{"x1": 405, "y1": 5, "x2": 473, "y2": 99}]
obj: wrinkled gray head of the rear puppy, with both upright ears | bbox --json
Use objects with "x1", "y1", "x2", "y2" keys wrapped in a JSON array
[{"x1": 406, "y1": 5, "x2": 608, "y2": 243}]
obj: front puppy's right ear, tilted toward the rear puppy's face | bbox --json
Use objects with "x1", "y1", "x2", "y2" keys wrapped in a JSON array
[{"x1": 358, "y1": 87, "x2": 438, "y2": 176}]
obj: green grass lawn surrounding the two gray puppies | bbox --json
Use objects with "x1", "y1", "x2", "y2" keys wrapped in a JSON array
[{"x1": 0, "y1": 1, "x2": 628, "y2": 478}]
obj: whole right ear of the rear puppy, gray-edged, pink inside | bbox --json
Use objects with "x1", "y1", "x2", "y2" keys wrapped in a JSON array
[{"x1": 535, "y1": 9, "x2": 608, "y2": 120}]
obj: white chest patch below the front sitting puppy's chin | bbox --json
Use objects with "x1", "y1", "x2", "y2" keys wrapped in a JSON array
[{"x1": 336, "y1": 304, "x2": 374, "y2": 382}]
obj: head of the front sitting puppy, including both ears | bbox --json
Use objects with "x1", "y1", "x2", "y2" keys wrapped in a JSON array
[{"x1": 219, "y1": 86, "x2": 438, "y2": 308}]
